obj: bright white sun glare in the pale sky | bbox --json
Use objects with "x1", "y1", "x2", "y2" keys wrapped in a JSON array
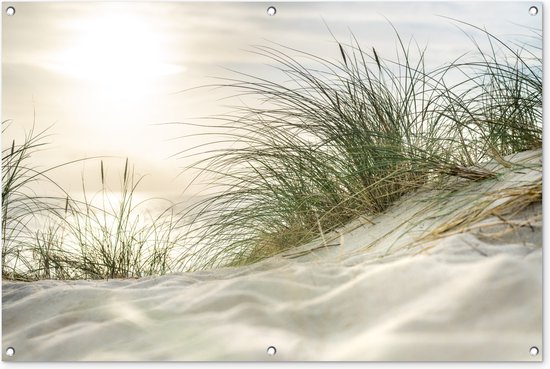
[{"x1": 47, "y1": 14, "x2": 183, "y2": 97}]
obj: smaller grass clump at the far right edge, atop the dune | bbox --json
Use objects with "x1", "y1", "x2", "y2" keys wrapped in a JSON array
[{"x1": 444, "y1": 22, "x2": 543, "y2": 160}]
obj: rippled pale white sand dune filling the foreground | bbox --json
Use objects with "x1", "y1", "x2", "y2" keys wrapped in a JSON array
[{"x1": 2, "y1": 152, "x2": 543, "y2": 361}]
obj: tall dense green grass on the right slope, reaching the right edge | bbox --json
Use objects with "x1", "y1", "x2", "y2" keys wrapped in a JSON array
[{"x1": 180, "y1": 24, "x2": 542, "y2": 267}]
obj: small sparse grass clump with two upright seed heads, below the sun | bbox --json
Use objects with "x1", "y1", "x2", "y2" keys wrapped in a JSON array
[{"x1": 55, "y1": 159, "x2": 188, "y2": 279}]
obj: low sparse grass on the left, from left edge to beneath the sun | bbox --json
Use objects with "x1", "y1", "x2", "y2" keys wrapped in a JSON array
[{"x1": 2, "y1": 123, "x2": 188, "y2": 281}]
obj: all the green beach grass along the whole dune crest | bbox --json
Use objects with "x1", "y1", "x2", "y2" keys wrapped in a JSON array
[{"x1": 2, "y1": 24, "x2": 542, "y2": 280}]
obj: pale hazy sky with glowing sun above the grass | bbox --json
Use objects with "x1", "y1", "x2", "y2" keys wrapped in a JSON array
[{"x1": 2, "y1": 2, "x2": 542, "y2": 199}]
